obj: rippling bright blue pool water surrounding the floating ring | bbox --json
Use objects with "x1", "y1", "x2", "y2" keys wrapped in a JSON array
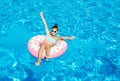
[{"x1": 0, "y1": 0, "x2": 120, "y2": 81}]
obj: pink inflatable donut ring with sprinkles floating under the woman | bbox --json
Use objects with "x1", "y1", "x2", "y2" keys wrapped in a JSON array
[{"x1": 28, "y1": 35, "x2": 67, "y2": 58}]
